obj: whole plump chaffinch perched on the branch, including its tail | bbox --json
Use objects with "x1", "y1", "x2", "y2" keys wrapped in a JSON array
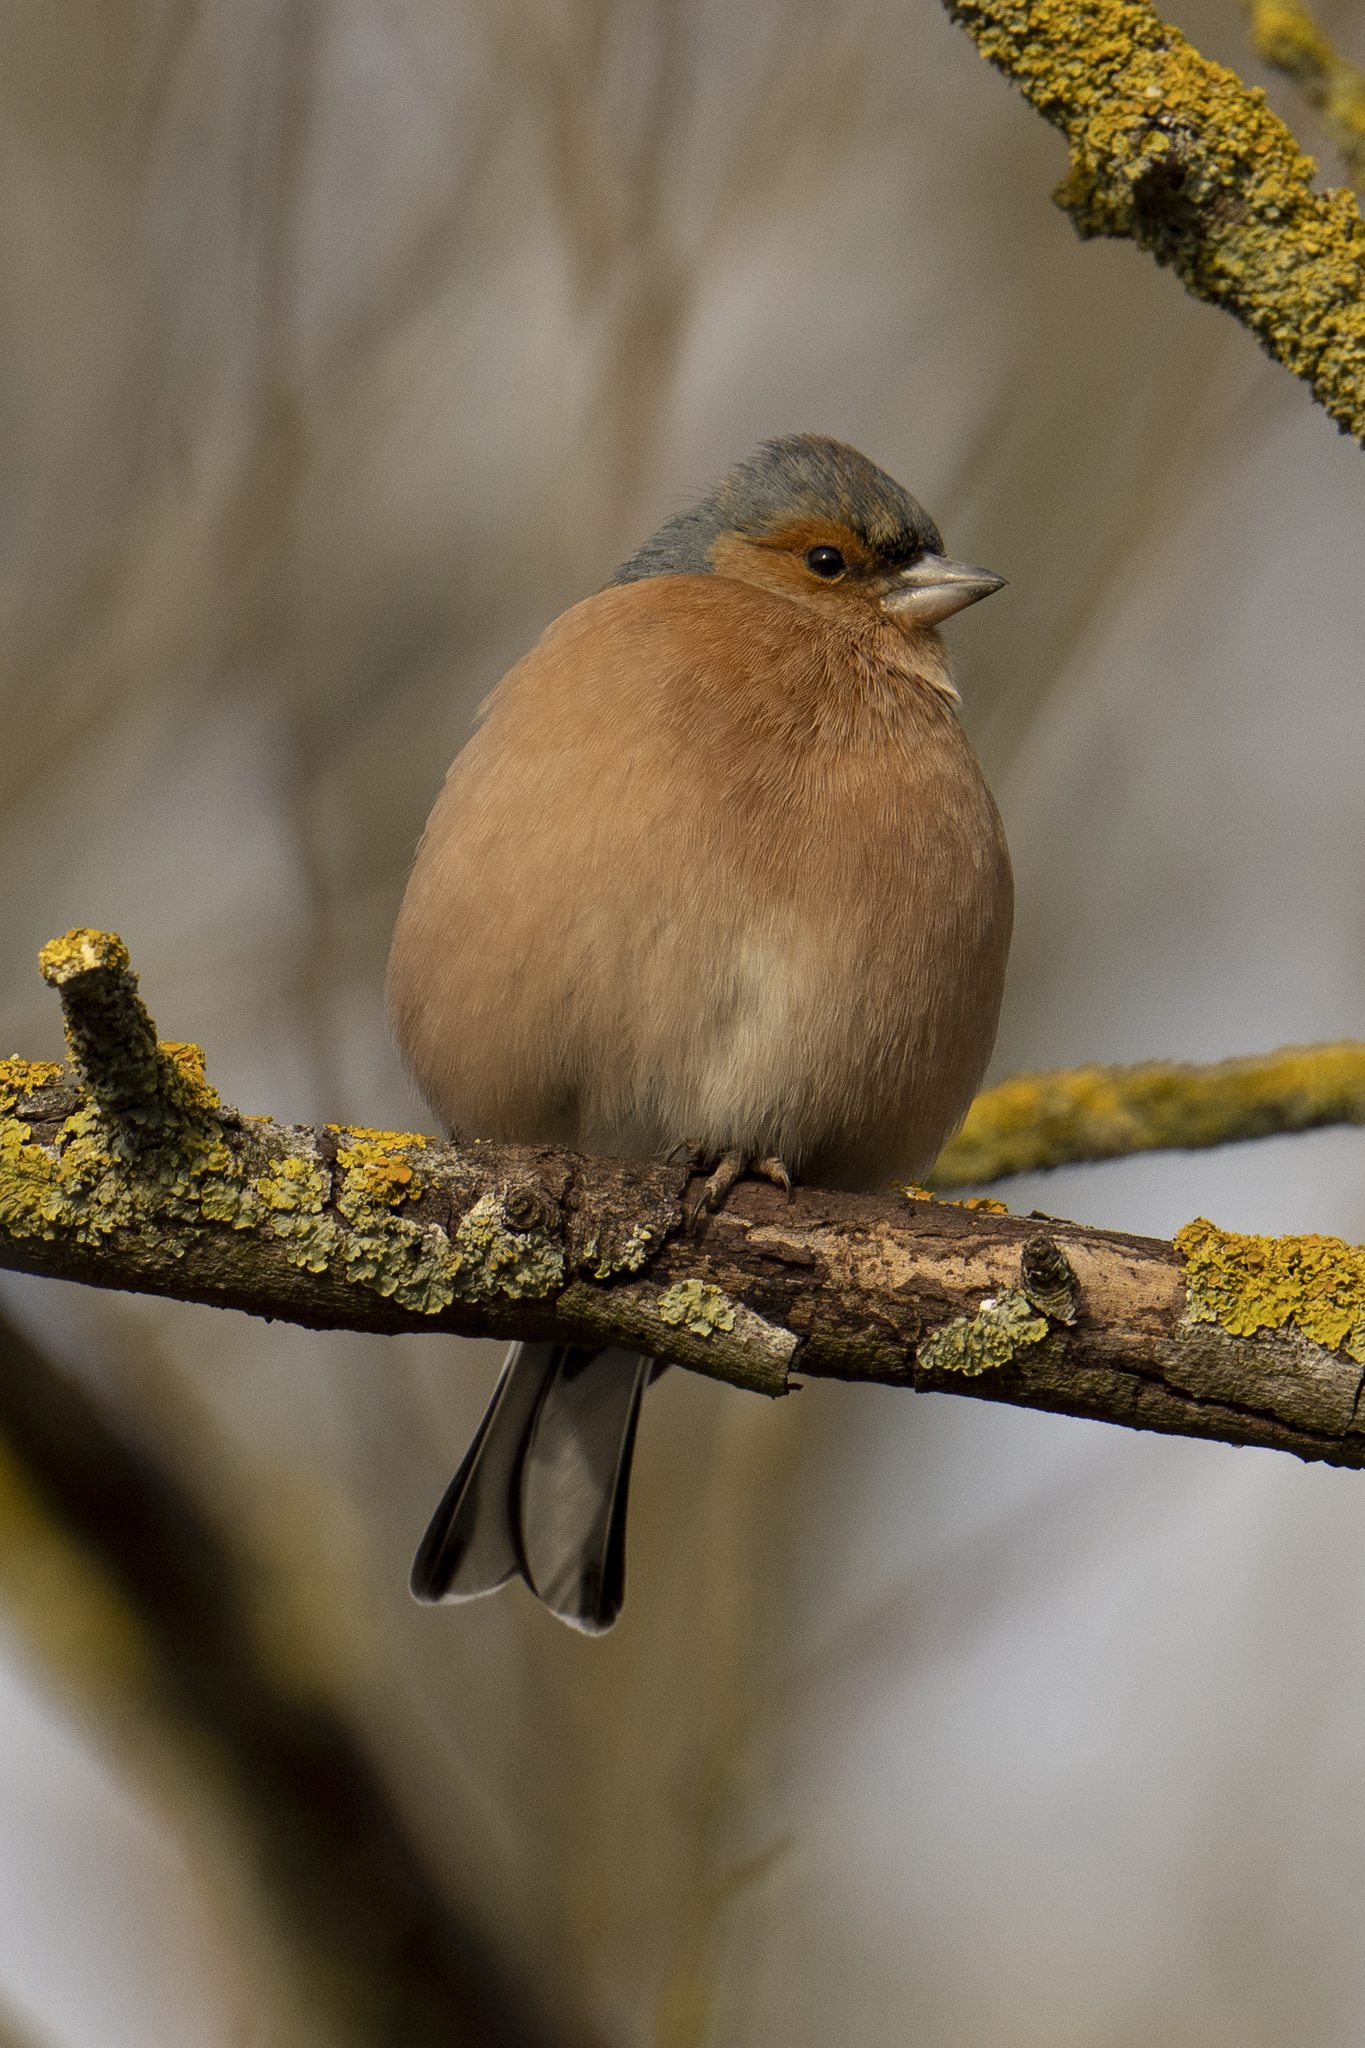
[{"x1": 389, "y1": 434, "x2": 1013, "y2": 1634}]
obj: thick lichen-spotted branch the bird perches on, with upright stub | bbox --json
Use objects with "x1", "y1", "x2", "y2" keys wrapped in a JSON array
[{"x1": 0, "y1": 932, "x2": 1365, "y2": 1466}]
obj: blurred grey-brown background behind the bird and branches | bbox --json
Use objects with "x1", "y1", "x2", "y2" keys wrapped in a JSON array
[{"x1": 0, "y1": 0, "x2": 1365, "y2": 2048}]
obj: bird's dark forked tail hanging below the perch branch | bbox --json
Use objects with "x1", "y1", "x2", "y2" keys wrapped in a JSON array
[{"x1": 411, "y1": 1343, "x2": 651, "y2": 1636}]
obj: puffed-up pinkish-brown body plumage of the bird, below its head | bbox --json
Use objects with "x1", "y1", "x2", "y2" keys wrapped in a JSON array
[{"x1": 391, "y1": 575, "x2": 1011, "y2": 1184}]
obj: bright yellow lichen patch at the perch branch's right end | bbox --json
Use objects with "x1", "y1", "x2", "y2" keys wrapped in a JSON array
[{"x1": 1175, "y1": 1217, "x2": 1365, "y2": 1364}]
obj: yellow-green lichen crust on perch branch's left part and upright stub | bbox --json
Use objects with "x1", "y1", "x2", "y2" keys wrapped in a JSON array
[{"x1": 0, "y1": 930, "x2": 589, "y2": 1315}]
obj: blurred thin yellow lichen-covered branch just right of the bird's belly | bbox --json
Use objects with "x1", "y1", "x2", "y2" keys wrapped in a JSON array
[{"x1": 931, "y1": 1040, "x2": 1365, "y2": 1190}]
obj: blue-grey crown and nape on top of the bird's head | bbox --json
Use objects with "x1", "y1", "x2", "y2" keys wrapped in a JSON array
[{"x1": 612, "y1": 434, "x2": 943, "y2": 584}]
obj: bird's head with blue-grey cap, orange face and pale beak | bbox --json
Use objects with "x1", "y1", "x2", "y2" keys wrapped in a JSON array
[{"x1": 612, "y1": 434, "x2": 1005, "y2": 629}]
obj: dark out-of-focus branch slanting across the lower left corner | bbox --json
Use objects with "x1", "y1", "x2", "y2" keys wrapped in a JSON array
[{"x1": 0, "y1": 1317, "x2": 583, "y2": 2048}]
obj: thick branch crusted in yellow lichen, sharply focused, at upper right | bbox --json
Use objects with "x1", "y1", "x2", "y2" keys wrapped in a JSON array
[{"x1": 945, "y1": 0, "x2": 1365, "y2": 440}]
